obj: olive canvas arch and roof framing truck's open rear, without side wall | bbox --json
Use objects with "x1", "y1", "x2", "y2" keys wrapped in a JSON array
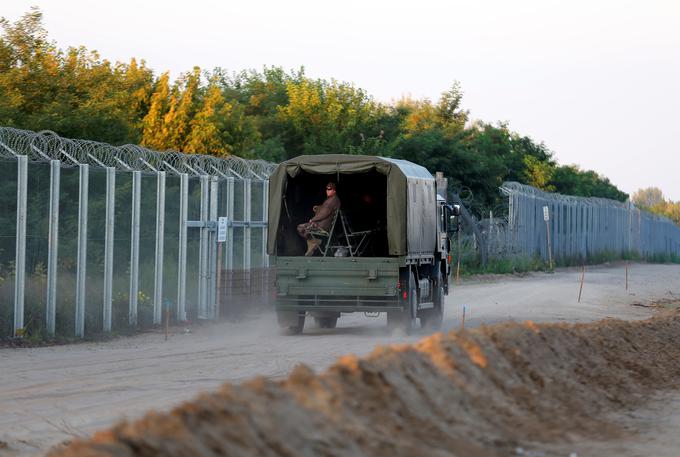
[{"x1": 267, "y1": 154, "x2": 433, "y2": 256}]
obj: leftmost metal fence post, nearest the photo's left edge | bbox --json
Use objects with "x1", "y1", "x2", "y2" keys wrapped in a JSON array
[{"x1": 14, "y1": 155, "x2": 28, "y2": 337}]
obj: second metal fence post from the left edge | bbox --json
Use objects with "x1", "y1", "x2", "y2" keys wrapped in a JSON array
[{"x1": 45, "y1": 160, "x2": 61, "y2": 335}]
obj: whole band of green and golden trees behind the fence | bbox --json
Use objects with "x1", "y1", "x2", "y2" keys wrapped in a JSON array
[{"x1": 0, "y1": 9, "x2": 627, "y2": 214}]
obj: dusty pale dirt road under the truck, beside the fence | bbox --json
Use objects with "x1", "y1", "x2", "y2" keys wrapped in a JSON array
[{"x1": 0, "y1": 264, "x2": 680, "y2": 455}]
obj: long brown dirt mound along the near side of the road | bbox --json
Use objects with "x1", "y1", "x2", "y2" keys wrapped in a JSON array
[{"x1": 50, "y1": 311, "x2": 680, "y2": 457}]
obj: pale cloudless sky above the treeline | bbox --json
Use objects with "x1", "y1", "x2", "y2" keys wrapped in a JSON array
[{"x1": 0, "y1": 0, "x2": 680, "y2": 201}]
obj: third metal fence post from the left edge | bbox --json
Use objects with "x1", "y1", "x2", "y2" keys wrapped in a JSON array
[{"x1": 75, "y1": 163, "x2": 90, "y2": 338}]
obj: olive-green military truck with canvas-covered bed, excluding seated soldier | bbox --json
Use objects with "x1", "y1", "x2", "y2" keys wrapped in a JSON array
[{"x1": 267, "y1": 154, "x2": 457, "y2": 334}]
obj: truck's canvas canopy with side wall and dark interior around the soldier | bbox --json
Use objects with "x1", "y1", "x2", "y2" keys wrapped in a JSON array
[{"x1": 267, "y1": 154, "x2": 437, "y2": 256}]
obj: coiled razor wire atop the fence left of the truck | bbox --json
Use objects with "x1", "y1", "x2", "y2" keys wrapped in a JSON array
[{"x1": 0, "y1": 127, "x2": 276, "y2": 180}]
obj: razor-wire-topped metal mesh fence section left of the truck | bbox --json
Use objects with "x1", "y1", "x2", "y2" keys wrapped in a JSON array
[{"x1": 0, "y1": 127, "x2": 274, "y2": 337}]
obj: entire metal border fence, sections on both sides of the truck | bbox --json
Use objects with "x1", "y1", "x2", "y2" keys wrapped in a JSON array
[{"x1": 5, "y1": 123, "x2": 680, "y2": 337}]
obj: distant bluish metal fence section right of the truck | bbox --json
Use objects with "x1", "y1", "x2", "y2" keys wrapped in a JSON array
[{"x1": 462, "y1": 182, "x2": 680, "y2": 263}]
